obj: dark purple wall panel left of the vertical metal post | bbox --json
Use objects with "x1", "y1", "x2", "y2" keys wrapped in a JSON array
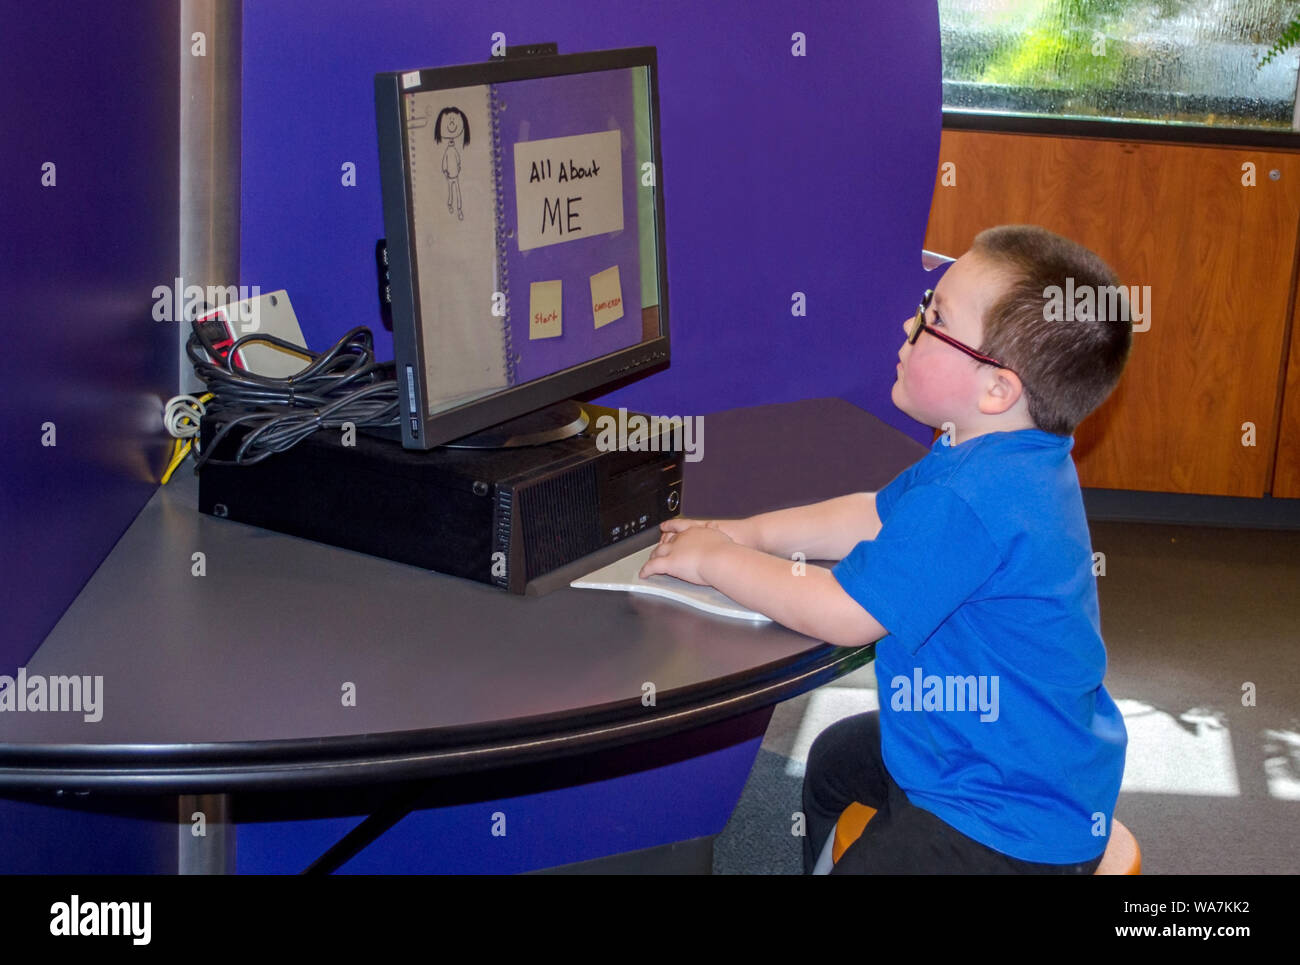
[{"x1": 0, "y1": 0, "x2": 179, "y2": 674}]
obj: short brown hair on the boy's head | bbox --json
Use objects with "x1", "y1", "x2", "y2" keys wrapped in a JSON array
[{"x1": 971, "y1": 225, "x2": 1132, "y2": 436}]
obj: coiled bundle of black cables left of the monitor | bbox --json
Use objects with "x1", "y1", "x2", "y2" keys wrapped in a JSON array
[{"x1": 185, "y1": 320, "x2": 400, "y2": 472}]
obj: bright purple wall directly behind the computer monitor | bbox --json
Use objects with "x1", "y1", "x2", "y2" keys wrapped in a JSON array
[{"x1": 242, "y1": 0, "x2": 941, "y2": 443}]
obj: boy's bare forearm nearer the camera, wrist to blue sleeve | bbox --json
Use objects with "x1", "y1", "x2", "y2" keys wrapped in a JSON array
[{"x1": 699, "y1": 544, "x2": 885, "y2": 646}]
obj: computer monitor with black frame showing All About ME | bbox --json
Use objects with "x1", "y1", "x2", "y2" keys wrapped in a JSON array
[{"x1": 374, "y1": 47, "x2": 670, "y2": 449}]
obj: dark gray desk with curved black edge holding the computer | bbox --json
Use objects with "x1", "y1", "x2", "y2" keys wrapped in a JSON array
[{"x1": 0, "y1": 399, "x2": 926, "y2": 879}]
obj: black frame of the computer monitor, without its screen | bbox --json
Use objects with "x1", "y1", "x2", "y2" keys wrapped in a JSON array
[{"x1": 374, "y1": 47, "x2": 671, "y2": 449}]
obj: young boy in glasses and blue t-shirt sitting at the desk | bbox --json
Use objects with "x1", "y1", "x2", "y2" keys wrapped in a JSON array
[{"x1": 641, "y1": 225, "x2": 1132, "y2": 874}]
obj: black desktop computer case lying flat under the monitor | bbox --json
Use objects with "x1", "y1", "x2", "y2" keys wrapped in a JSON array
[{"x1": 199, "y1": 403, "x2": 683, "y2": 593}]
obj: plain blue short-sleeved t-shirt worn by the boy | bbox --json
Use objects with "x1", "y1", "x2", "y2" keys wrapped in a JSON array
[{"x1": 832, "y1": 429, "x2": 1127, "y2": 864}]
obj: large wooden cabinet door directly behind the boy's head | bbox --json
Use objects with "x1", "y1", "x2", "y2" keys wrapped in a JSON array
[{"x1": 926, "y1": 130, "x2": 1300, "y2": 497}]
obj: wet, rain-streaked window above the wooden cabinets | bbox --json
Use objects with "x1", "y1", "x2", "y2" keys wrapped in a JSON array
[{"x1": 939, "y1": 0, "x2": 1300, "y2": 130}]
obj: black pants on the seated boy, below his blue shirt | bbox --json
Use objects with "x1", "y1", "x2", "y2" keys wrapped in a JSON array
[{"x1": 803, "y1": 710, "x2": 1105, "y2": 874}]
